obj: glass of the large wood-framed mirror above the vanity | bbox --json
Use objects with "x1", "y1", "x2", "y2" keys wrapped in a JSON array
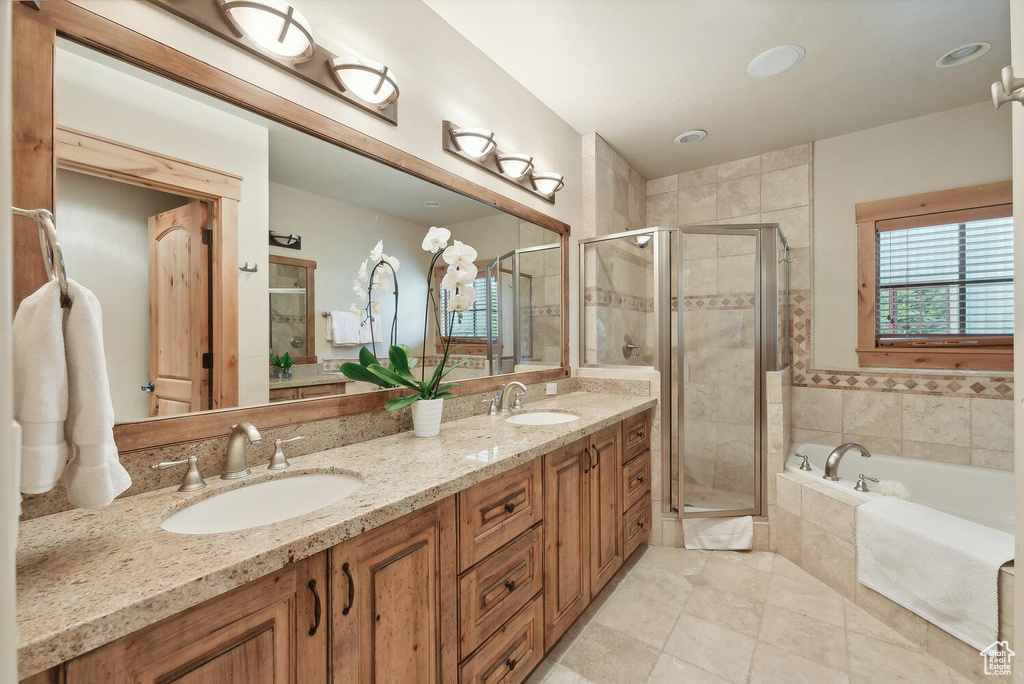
[{"x1": 54, "y1": 40, "x2": 563, "y2": 422}]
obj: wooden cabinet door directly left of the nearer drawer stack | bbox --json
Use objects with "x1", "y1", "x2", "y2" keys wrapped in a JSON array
[{"x1": 331, "y1": 498, "x2": 459, "y2": 684}]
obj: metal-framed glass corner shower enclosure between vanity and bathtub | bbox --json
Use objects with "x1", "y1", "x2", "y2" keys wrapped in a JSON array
[{"x1": 580, "y1": 224, "x2": 790, "y2": 517}]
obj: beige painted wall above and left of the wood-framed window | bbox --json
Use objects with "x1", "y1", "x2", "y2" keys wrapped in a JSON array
[{"x1": 812, "y1": 101, "x2": 1011, "y2": 369}]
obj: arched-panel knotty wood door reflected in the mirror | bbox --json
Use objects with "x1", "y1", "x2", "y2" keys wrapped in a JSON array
[{"x1": 150, "y1": 202, "x2": 210, "y2": 416}]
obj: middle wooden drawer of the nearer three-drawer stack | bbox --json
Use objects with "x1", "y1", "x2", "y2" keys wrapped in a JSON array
[{"x1": 459, "y1": 525, "x2": 544, "y2": 657}]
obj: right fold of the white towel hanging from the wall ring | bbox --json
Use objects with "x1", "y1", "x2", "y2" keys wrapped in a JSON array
[{"x1": 65, "y1": 280, "x2": 131, "y2": 508}]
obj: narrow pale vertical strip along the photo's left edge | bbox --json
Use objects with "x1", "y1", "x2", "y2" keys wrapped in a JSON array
[{"x1": 0, "y1": 2, "x2": 18, "y2": 682}]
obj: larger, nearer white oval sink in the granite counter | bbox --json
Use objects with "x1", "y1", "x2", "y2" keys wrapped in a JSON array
[{"x1": 160, "y1": 473, "x2": 362, "y2": 535}]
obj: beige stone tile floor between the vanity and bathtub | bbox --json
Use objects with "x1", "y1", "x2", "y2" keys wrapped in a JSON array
[{"x1": 527, "y1": 547, "x2": 983, "y2": 684}]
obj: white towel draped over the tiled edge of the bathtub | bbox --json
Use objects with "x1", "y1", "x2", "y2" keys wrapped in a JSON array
[{"x1": 857, "y1": 497, "x2": 1014, "y2": 650}]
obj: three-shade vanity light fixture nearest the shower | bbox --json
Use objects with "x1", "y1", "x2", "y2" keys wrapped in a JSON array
[{"x1": 441, "y1": 121, "x2": 565, "y2": 204}]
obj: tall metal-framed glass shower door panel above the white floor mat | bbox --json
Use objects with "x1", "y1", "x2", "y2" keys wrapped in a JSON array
[{"x1": 678, "y1": 226, "x2": 761, "y2": 516}]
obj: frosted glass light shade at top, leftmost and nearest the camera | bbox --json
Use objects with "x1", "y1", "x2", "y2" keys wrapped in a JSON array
[{"x1": 220, "y1": 0, "x2": 315, "y2": 62}]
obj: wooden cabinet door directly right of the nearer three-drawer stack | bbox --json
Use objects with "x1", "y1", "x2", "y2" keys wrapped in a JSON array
[{"x1": 544, "y1": 438, "x2": 591, "y2": 648}]
